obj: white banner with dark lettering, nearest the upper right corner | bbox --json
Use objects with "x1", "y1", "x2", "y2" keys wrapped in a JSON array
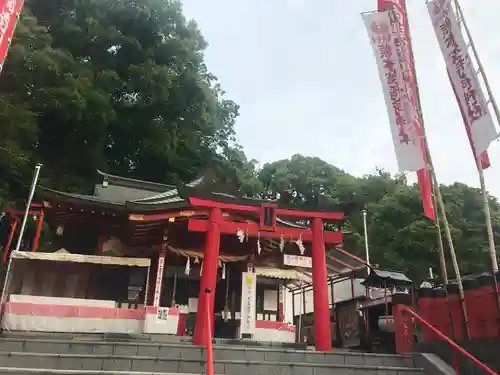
[{"x1": 427, "y1": 0, "x2": 498, "y2": 158}]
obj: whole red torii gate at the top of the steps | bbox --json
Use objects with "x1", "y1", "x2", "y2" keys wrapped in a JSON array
[{"x1": 188, "y1": 197, "x2": 344, "y2": 352}]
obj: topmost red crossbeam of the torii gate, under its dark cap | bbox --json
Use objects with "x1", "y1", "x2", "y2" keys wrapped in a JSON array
[{"x1": 189, "y1": 197, "x2": 344, "y2": 220}]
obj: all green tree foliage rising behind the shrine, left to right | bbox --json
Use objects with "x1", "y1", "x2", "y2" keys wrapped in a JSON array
[{"x1": 0, "y1": 0, "x2": 500, "y2": 277}]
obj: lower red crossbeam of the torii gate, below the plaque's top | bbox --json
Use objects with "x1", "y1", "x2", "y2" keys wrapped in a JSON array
[{"x1": 188, "y1": 219, "x2": 342, "y2": 244}]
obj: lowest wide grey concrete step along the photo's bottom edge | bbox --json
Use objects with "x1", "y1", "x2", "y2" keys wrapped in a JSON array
[{"x1": 0, "y1": 352, "x2": 423, "y2": 375}]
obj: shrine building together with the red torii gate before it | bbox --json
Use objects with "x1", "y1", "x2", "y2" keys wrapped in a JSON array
[{"x1": 2, "y1": 171, "x2": 364, "y2": 351}]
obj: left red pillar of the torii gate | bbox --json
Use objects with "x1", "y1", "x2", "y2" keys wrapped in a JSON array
[{"x1": 193, "y1": 208, "x2": 222, "y2": 345}]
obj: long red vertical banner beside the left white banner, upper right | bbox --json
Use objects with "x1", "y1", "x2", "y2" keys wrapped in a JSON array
[{"x1": 377, "y1": 0, "x2": 436, "y2": 220}]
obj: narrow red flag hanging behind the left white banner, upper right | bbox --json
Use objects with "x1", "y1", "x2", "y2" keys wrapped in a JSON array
[{"x1": 378, "y1": 0, "x2": 436, "y2": 221}]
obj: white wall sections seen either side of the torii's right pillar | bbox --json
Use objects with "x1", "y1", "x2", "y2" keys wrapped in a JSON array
[{"x1": 285, "y1": 279, "x2": 365, "y2": 322}]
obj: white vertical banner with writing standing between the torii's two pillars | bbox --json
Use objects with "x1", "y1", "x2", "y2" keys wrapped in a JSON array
[{"x1": 240, "y1": 272, "x2": 257, "y2": 338}]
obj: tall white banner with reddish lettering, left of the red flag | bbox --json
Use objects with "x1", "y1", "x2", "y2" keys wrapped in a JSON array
[{"x1": 363, "y1": 10, "x2": 425, "y2": 172}]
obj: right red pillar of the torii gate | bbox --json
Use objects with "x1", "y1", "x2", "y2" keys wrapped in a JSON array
[{"x1": 312, "y1": 218, "x2": 332, "y2": 352}]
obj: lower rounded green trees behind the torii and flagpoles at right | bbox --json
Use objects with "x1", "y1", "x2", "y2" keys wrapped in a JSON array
[{"x1": 259, "y1": 155, "x2": 500, "y2": 280}]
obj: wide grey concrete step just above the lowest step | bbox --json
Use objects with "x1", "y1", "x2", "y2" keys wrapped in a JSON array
[{"x1": 0, "y1": 338, "x2": 414, "y2": 368}]
